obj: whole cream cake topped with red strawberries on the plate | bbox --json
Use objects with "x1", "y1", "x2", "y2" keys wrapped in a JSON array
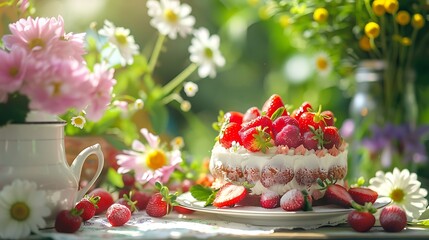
[{"x1": 209, "y1": 94, "x2": 347, "y2": 200}]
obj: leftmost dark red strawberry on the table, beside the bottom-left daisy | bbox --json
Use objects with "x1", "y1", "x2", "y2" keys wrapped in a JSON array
[{"x1": 55, "y1": 208, "x2": 82, "y2": 233}]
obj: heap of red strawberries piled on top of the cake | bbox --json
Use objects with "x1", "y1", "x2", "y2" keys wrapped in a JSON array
[{"x1": 217, "y1": 94, "x2": 343, "y2": 152}]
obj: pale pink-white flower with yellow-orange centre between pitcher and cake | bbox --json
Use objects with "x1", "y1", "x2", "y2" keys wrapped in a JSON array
[{"x1": 116, "y1": 128, "x2": 182, "y2": 184}]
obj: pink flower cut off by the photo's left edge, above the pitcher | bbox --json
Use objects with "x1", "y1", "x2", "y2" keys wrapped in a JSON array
[{"x1": 0, "y1": 48, "x2": 26, "y2": 93}]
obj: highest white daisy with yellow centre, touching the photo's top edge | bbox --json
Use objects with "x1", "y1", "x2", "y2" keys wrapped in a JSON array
[{"x1": 146, "y1": 0, "x2": 195, "y2": 39}]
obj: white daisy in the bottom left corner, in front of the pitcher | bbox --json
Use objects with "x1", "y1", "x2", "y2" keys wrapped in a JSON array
[{"x1": 0, "y1": 179, "x2": 51, "y2": 239}]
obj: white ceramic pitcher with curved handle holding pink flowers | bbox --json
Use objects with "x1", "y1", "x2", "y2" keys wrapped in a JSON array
[{"x1": 0, "y1": 111, "x2": 104, "y2": 227}]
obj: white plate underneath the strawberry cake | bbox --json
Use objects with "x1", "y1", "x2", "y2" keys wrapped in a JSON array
[{"x1": 177, "y1": 192, "x2": 390, "y2": 229}]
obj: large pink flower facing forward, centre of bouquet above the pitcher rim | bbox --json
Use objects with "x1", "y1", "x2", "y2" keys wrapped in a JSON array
[{"x1": 21, "y1": 58, "x2": 94, "y2": 114}]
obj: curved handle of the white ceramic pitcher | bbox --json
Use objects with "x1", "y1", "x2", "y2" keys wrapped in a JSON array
[{"x1": 70, "y1": 143, "x2": 104, "y2": 202}]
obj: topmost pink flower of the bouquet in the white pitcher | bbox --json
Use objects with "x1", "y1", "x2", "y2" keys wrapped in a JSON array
[{"x1": 3, "y1": 16, "x2": 64, "y2": 56}]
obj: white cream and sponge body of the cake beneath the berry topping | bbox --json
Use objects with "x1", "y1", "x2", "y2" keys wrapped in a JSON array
[{"x1": 209, "y1": 143, "x2": 347, "y2": 199}]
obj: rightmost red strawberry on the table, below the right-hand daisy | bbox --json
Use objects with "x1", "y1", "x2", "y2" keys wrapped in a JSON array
[{"x1": 380, "y1": 205, "x2": 407, "y2": 232}]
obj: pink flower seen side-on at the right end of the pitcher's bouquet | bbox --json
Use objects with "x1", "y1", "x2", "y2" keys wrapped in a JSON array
[{"x1": 86, "y1": 64, "x2": 116, "y2": 121}]
